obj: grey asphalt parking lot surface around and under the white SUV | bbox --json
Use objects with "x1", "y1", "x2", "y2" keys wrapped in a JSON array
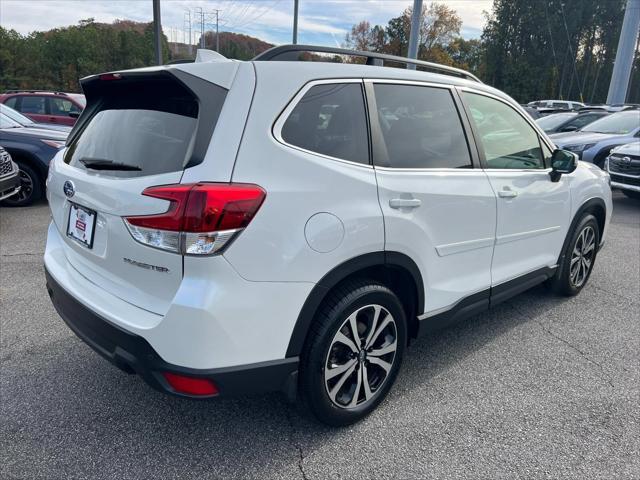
[{"x1": 0, "y1": 194, "x2": 640, "y2": 479}]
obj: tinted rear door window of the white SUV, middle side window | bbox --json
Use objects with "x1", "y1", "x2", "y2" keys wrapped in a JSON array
[{"x1": 374, "y1": 84, "x2": 471, "y2": 168}]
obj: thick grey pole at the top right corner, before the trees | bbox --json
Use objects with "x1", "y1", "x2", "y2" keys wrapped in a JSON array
[{"x1": 607, "y1": 0, "x2": 640, "y2": 104}]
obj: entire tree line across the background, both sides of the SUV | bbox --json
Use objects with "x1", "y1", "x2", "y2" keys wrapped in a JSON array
[{"x1": 0, "y1": 0, "x2": 640, "y2": 103}]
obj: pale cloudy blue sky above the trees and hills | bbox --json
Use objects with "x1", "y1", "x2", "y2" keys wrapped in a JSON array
[{"x1": 0, "y1": 0, "x2": 492, "y2": 46}]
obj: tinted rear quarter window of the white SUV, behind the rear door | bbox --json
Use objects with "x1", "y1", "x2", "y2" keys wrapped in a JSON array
[{"x1": 282, "y1": 83, "x2": 369, "y2": 163}]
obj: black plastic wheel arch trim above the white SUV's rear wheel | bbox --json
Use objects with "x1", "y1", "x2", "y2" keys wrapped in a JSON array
[{"x1": 286, "y1": 251, "x2": 424, "y2": 357}]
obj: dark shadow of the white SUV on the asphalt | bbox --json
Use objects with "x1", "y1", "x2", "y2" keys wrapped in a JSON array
[{"x1": 2, "y1": 282, "x2": 564, "y2": 478}]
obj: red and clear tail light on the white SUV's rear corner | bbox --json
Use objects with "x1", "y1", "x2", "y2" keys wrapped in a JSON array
[{"x1": 124, "y1": 183, "x2": 266, "y2": 255}]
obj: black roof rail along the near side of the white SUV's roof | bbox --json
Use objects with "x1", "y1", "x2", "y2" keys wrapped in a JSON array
[{"x1": 252, "y1": 45, "x2": 482, "y2": 83}]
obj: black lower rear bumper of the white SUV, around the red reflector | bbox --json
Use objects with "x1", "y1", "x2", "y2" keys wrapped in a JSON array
[{"x1": 45, "y1": 267, "x2": 298, "y2": 398}]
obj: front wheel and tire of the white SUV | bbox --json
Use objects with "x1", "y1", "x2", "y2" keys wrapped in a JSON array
[{"x1": 548, "y1": 213, "x2": 600, "y2": 296}]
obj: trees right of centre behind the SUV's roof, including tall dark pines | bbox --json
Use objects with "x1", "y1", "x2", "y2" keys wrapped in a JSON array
[{"x1": 345, "y1": 0, "x2": 640, "y2": 103}]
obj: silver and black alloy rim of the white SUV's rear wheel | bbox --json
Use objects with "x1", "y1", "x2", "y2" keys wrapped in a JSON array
[{"x1": 324, "y1": 304, "x2": 398, "y2": 409}]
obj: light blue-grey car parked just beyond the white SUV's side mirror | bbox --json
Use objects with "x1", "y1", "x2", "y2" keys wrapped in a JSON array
[{"x1": 550, "y1": 110, "x2": 640, "y2": 168}]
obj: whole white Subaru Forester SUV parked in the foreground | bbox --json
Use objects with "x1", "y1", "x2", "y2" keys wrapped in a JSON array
[{"x1": 44, "y1": 45, "x2": 612, "y2": 425}]
